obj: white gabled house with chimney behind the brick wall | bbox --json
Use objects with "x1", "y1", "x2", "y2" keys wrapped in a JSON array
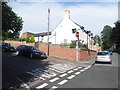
[{"x1": 43, "y1": 9, "x2": 93, "y2": 48}]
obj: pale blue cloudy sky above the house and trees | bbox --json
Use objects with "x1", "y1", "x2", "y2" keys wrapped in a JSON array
[{"x1": 8, "y1": 0, "x2": 118, "y2": 35}]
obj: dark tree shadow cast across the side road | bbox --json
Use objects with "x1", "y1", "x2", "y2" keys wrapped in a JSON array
[{"x1": 2, "y1": 52, "x2": 51, "y2": 89}]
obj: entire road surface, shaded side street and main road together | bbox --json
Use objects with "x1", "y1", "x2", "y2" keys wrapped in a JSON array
[{"x1": 2, "y1": 53, "x2": 120, "y2": 89}]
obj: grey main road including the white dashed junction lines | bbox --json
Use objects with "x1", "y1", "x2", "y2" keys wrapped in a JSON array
[{"x1": 33, "y1": 53, "x2": 120, "y2": 90}]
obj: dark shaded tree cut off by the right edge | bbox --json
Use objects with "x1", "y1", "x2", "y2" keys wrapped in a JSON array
[{"x1": 110, "y1": 20, "x2": 120, "y2": 48}]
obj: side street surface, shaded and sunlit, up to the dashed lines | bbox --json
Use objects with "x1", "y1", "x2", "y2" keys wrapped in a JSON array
[{"x1": 2, "y1": 52, "x2": 81, "y2": 89}]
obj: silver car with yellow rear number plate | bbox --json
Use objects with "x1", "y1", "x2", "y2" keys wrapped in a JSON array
[{"x1": 95, "y1": 51, "x2": 112, "y2": 63}]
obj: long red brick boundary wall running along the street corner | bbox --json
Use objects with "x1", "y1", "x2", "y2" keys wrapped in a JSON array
[{"x1": 4, "y1": 41, "x2": 96, "y2": 61}]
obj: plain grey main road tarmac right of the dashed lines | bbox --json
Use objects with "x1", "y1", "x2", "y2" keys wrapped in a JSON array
[{"x1": 62, "y1": 54, "x2": 118, "y2": 88}]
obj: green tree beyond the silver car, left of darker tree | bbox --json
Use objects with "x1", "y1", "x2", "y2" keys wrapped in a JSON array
[{"x1": 101, "y1": 25, "x2": 112, "y2": 50}]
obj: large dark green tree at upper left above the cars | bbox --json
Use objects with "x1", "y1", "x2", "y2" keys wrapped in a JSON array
[{"x1": 2, "y1": 2, "x2": 23, "y2": 39}]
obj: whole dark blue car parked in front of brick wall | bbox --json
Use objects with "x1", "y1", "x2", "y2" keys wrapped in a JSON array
[{"x1": 16, "y1": 45, "x2": 47, "y2": 59}]
